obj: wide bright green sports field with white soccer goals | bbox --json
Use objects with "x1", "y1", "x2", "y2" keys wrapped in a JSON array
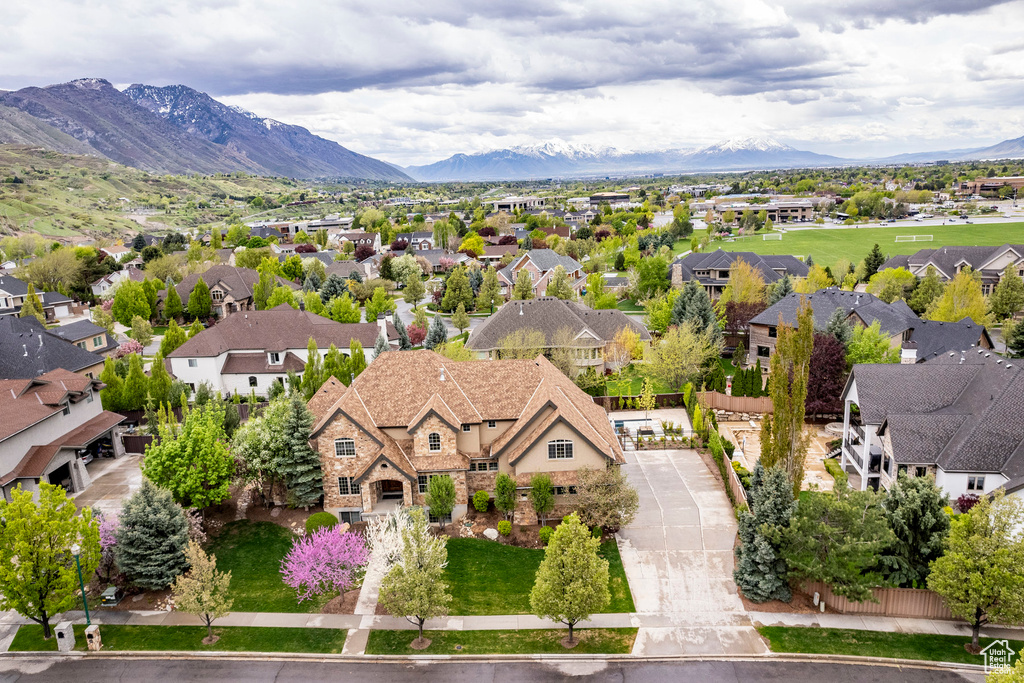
[{"x1": 708, "y1": 222, "x2": 1024, "y2": 265}]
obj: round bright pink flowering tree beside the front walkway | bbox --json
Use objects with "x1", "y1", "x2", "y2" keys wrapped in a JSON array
[{"x1": 281, "y1": 527, "x2": 370, "y2": 602}]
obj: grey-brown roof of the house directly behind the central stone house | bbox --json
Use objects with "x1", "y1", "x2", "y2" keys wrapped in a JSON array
[{"x1": 466, "y1": 297, "x2": 650, "y2": 351}]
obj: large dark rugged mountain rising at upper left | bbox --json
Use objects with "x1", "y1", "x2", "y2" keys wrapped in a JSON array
[{"x1": 0, "y1": 78, "x2": 411, "y2": 181}]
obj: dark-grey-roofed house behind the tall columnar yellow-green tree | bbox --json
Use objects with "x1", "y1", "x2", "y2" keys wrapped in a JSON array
[{"x1": 750, "y1": 287, "x2": 992, "y2": 371}]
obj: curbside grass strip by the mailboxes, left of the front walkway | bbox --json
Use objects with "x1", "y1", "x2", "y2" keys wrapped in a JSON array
[{"x1": 10, "y1": 625, "x2": 346, "y2": 653}]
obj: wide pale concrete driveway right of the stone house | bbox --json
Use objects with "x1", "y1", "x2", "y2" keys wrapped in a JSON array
[{"x1": 618, "y1": 450, "x2": 767, "y2": 655}]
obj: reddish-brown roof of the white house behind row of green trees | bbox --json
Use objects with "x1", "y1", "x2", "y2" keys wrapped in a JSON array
[{"x1": 167, "y1": 304, "x2": 398, "y2": 358}]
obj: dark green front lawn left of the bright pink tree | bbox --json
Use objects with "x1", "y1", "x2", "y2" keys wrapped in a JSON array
[{"x1": 209, "y1": 520, "x2": 335, "y2": 612}]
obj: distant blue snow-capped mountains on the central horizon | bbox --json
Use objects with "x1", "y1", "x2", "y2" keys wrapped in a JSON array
[{"x1": 406, "y1": 137, "x2": 843, "y2": 181}]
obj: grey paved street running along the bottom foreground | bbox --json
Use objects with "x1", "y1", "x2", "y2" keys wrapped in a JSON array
[{"x1": 0, "y1": 656, "x2": 984, "y2": 683}]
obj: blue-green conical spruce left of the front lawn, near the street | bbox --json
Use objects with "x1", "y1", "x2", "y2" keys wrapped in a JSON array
[{"x1": 114, "y1": 478, "x2": 188, "y2": 591}]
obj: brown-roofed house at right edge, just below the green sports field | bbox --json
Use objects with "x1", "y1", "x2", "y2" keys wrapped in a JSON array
[{"x1": 880, "y1": 244, "x2": 1024, "y2": 296}]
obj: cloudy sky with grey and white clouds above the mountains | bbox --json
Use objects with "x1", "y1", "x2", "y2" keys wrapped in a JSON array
[{"x1": 0, "y1": 0, "x2": 1024, "y2": 164}]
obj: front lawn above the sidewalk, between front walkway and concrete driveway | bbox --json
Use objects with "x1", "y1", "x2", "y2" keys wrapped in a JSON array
[{"x1": 444, "y1": 539, "x2": 634, "y2": 615}]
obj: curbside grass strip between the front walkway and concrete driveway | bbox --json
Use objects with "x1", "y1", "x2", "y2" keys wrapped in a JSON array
[{"x1": 367, "y1": 629, "x2": 637, "y2": 654}]
